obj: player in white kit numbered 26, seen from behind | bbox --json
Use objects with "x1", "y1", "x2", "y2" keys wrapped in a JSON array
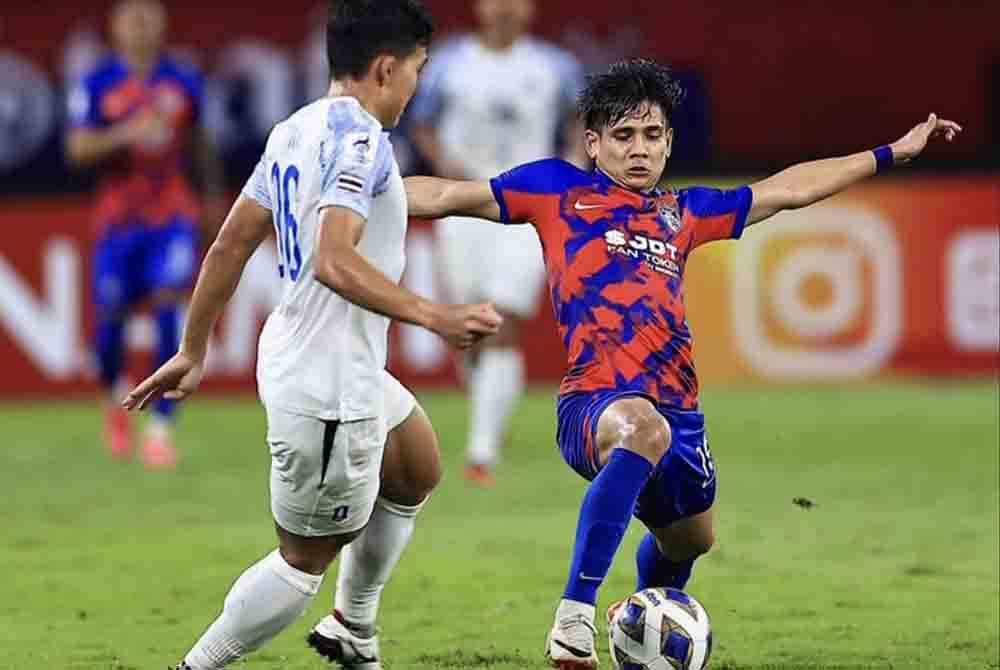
[{"x1": 124, "y1": 0, "x2": 501, "y2": 670}]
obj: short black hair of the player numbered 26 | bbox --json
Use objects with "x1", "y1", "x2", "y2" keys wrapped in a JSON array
[{"x1": 326, "y1": 0, "x2": 434, "y2": 79}]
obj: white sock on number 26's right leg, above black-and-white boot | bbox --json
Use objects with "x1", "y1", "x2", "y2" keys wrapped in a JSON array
[{"x1": 334, "y1": 498, "x2": 424, "y2": 635}]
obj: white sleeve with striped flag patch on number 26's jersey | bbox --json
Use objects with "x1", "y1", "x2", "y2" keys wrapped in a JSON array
[{"x1": 319, "y1": 104, "x2": 391, "y2": 219}]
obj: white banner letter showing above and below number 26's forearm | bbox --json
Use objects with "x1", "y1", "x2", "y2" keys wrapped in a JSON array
[{"x1": 390, "y1": 229, "x2": 448, "y2": 372}]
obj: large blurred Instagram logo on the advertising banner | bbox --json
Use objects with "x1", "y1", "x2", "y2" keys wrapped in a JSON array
[{"x1": 731, "y1": 207, "x2": 902, "y2": 378}]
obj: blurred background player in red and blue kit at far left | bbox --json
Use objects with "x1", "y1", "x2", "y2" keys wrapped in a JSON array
[{"x1": 66, "y1": 0, "x2": 220, "y2": 468}]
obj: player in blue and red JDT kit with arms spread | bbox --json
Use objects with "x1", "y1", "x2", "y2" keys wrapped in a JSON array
[{"x1": 406, "y1": 61, "x2": 961, "y2": 669}]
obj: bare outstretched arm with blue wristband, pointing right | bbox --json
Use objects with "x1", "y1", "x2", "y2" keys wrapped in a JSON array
[{"x1": 747, "y1": 114, "x2": 962, "y2": 225}]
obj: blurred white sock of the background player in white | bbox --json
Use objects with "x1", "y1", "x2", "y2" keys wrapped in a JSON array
[{"x1": 466, "y1": 349, "x2": 524, "y2": 466}]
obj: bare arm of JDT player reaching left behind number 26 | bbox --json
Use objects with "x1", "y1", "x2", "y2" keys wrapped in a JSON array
[{"x1": 403, "y1": 177, "x2": 501, "y2": 221}]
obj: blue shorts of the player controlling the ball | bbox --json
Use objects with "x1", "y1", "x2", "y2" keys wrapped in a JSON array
[{"x1": 556, "y1": 391, "x2": 716, "y2": 528}]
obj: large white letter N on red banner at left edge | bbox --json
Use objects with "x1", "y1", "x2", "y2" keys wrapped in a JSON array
[{"x1": 0, "y1": 237, "x2": 80, "y2": 379}]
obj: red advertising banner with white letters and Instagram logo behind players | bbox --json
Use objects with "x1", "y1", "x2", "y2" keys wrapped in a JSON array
[{"x1": 0, "y1": 177, "x2": 1000, "y2": 399}]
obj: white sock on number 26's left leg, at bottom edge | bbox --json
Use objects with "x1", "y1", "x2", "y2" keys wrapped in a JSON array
[{"x1": 184, "y1": 549, "x2": 323, "y2": 670}]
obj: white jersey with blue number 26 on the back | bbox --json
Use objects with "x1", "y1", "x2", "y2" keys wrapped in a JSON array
[{"x1": 243, "y1": 97, "x2": 407, "y2": 421}]
